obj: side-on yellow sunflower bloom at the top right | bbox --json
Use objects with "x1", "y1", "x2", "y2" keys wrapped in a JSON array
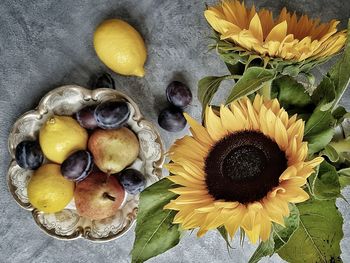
[{"x1": 204, "y1": 0, "x2": 346, "y2": 62}]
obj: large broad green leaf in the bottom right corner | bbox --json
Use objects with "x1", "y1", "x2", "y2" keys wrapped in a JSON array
[{"x1": 278, "y1": 200, "x2": 343, "y2": 263}]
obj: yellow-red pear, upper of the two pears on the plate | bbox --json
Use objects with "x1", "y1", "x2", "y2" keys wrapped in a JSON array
[{"x1": 88, "y1": 127, "x2": 140, "y2": 174}]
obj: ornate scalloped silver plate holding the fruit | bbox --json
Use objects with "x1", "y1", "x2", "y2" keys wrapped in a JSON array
[{"x1": 7, "y1": 85, "x2": 164, "y2": 242}]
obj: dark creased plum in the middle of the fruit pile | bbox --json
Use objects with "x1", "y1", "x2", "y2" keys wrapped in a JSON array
[{"x1": 61, "y1": 150, "x2": 93, "y2": 182}]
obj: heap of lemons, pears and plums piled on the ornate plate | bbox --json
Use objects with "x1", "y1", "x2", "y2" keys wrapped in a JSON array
[{"x1": 16, "y1": 101, "x2": 146, "y2": 220}]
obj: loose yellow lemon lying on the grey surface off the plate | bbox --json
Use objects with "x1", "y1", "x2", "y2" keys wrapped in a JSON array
[{"x1": 94, "y1": 19, "x2": 147, "y2": 77}]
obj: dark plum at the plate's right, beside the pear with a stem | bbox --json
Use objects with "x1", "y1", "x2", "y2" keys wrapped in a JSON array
[{"x1": 117, "y1": 169, "x2": 146, "y2": 195}]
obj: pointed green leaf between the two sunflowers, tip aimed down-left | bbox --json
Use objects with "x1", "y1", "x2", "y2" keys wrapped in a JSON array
[{"x1": 226, "y1": 67, "x2": 275, "y2": 104}]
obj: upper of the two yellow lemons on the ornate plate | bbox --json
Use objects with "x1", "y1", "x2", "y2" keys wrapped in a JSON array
[{"x1": 39, "y1": 115, "x2": 88, "y2": 164}]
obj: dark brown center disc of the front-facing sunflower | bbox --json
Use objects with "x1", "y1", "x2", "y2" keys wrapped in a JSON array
[{"x1": 205, "y1": 131, "x2": 287, "y2": 204}]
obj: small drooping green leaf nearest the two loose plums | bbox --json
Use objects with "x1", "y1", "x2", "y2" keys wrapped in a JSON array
[{"x1": 198, "y1": 76, "x2": 230, "y2": 108}]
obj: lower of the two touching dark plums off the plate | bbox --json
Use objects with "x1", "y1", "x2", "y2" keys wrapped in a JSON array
[{"x1": 158, "y1": 107, "x2": 187, "y2": 132}]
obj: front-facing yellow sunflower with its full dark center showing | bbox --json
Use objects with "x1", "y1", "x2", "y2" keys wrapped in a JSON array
[{"x1": 164, "y1": 95, "x2": 323, "y2": 243}]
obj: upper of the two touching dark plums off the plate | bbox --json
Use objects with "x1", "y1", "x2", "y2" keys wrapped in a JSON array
[{"x1": 166, "y1": 81, "x2": 192, "y2": 108}]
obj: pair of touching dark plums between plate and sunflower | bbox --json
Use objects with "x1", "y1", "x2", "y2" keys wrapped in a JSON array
[{"x1": 158, "y1": 81, "x2": 192, "y2": 132}]
